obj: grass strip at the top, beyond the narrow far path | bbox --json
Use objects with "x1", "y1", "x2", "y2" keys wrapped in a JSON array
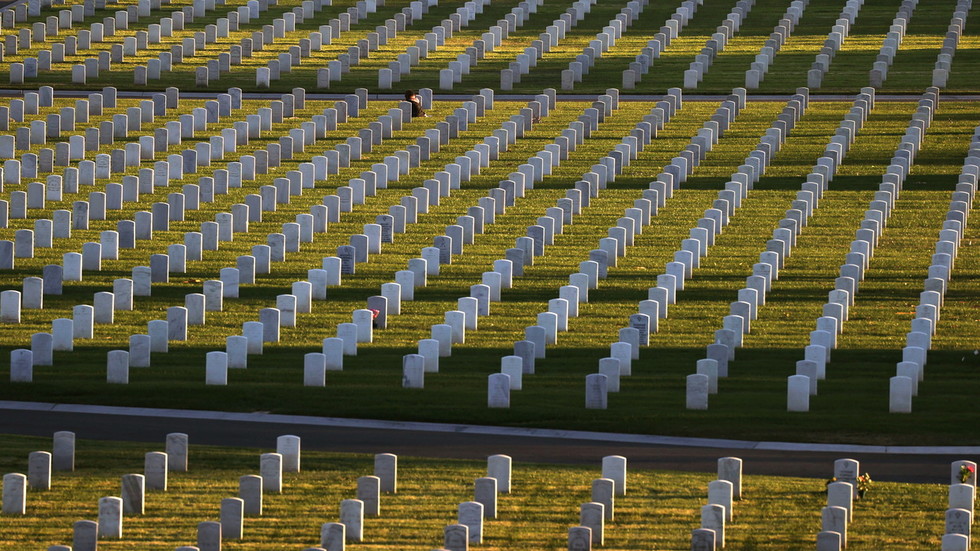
[{"x1": 0, "y1": 0, "x2": 980, "y2": 94}]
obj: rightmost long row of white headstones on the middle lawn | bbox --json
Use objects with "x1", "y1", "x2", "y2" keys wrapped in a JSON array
[{"x1": 889, "y1": 117, "x2": 968, "y2": 413}]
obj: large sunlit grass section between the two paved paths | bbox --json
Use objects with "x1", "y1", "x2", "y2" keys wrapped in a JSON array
[{"x1": 0, "y1": 96, "x2": 980, "y2": 444}]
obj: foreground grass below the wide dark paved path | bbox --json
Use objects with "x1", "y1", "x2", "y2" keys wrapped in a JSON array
[{"x1": 0, "y1": 435, "x2": 947, "y2": 551}]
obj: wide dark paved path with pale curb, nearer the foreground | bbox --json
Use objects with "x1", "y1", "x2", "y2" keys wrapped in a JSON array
[{"x1": 0, "y1": 401, "x2": 968, "y2": 484}]
